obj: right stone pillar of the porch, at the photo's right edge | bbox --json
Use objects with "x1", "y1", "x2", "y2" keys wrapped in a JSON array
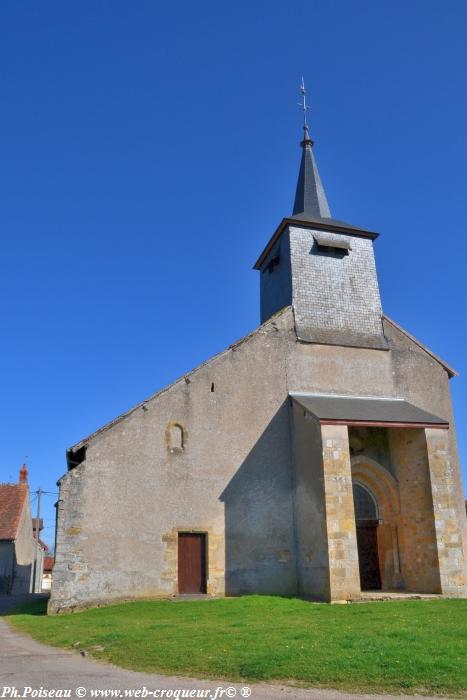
[{"x1": 425, "y1": 428, "x2": 467, "y2": 597}]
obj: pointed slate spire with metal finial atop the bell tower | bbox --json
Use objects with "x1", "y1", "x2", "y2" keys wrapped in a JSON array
[{"x1": 293, "y1": 78, "x2": 331, "y2": 219}]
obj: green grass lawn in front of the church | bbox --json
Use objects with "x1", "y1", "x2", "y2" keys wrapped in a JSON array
[{"x1": 3, "y1": 596, "x2": 467, "y2": 697}]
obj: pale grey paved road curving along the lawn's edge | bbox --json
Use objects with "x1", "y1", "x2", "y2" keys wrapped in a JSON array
[{"x1": 0, "y1": 596, "x2": 454, "y2": 700}]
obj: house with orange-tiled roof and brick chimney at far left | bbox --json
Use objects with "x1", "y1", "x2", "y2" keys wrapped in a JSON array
[{"x1": 0, "y1": 464, "x2": 44, "y2": 593}]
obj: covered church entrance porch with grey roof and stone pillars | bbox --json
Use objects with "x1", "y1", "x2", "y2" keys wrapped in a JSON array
[{"x1": 291, "y1": 394, "x2": 465, "y2": 601}]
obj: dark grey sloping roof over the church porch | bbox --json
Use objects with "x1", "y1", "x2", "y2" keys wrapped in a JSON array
[{"x1": 290, "y1": 393, "x2": 449, "y2": 429}]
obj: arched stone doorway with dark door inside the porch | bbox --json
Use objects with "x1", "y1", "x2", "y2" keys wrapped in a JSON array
[{"x1": 351, "y1": 455, "x2": 404, "y2": 591}]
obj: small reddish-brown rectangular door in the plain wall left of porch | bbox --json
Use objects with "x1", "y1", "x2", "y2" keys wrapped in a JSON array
[{"x1": 178, "y1": 532, "x2": 206, "y2": 593}]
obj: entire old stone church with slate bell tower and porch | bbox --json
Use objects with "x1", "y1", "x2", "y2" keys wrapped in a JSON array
[{"x1": 49, "y1": 105, "x2": 467, "y2": 613}]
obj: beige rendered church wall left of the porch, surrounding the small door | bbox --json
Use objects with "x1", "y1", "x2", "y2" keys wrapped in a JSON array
[{"x1": 50, "y1": 312, "x2": 296, "y2": 612}]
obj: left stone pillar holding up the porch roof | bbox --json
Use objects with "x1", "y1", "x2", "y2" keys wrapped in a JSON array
[{"x1": 321, "y1": 425, "x2": 361, "y2": 602}]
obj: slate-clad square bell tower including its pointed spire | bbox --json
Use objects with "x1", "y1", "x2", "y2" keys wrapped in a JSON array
[{"x1": 255, "y1": 80, "x2": 387, "y2": 350}]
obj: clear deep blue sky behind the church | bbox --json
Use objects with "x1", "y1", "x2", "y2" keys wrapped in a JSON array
[{"x1": 0, "y1": 0, "x2": 467, "y2": 542}]
